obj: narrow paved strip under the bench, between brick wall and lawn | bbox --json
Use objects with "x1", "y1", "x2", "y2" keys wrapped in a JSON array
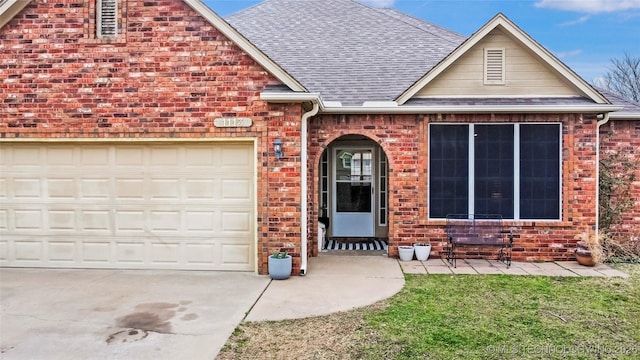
[{"x1": 399, "y1": 259, "x2": 629, "y2": 277}]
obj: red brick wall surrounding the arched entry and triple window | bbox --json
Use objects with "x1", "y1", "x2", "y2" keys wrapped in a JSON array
[{"x1": 309, "y1": 114, "x2": 596, "y2": 261}]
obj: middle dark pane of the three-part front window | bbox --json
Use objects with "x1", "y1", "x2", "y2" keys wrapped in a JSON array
[{"x1": 474, "y1": 125, "x2": 514, "y2": 219}]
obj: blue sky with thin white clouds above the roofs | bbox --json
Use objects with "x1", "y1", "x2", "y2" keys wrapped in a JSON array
[{"x1": 202, "y1": 0, "x2": 640, "y2": 83}]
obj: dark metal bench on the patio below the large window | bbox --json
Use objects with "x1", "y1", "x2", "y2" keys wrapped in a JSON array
[{"x1": 446, "y1": 214, "x2": 513, "y2": 268}]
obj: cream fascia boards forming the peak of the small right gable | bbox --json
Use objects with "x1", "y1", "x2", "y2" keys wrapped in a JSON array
[{"x1": 396, "y1": 13, "x2": 609, "y2": 104}]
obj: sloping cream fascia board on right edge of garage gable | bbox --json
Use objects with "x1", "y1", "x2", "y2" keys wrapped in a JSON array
[{"x1": 183, "y1": 0, "x2": 307, "y2": 92}]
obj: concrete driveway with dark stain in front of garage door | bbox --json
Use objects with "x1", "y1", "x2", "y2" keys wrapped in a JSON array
[{"x1": 0, "y1": 268, "x2": 270, "y2": 360}]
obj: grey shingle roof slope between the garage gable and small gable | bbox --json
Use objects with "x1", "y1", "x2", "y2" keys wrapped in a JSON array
[{"x1": 226, "y1": 0, "x2": 465, "y2": 105}]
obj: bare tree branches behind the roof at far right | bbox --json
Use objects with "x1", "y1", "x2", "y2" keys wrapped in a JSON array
[{"x1": 597, "y1": 53, "x2": 640, "y2": 102}]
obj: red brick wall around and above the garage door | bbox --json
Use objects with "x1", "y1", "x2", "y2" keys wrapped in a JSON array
[{"x1": 0, "y1": 0, "x2": 301, "y2": 273}]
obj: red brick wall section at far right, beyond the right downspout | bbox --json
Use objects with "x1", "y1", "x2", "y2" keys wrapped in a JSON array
[{"x1": 600, "y1": 120, "x2": 640, "y2": 242}]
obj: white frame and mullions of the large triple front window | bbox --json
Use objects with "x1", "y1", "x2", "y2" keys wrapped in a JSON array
[{"x1": 427, "y1": 122, "x2": 564, "y2": 222}]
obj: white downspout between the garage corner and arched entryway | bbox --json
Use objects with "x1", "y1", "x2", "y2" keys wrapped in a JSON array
[{"x1": 300, "y1": 101, "x2": 320, "y2": 276}]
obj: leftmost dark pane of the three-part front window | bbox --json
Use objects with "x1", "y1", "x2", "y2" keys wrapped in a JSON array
[{"x1": 429, "y1": 125, "x2": 469, "y2": 218}]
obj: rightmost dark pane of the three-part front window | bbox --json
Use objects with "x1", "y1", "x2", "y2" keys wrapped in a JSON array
[{"x1": 520, "y1": 124, "x2": 560, "y2": 219}]
